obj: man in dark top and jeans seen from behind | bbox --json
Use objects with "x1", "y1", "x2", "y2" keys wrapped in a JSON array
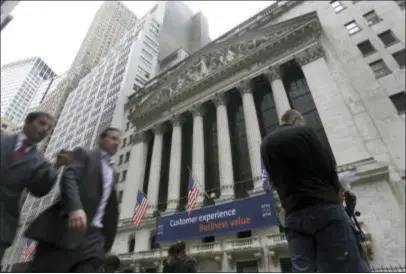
[{"x1": 261, "y1": 110, "x2": 369, "y2": 272}]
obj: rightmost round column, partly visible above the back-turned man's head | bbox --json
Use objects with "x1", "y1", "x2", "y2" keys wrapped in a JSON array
[{"x1": 264, "y1": 67, "x2": 291, "y2": 121}]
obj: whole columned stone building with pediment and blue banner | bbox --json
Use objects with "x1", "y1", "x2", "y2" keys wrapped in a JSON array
[{"x1": 112, "y1": 1, "x2": 405, "y2": 272}]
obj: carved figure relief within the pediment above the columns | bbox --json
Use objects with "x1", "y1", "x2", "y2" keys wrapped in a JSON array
[{"x1": 135, "y1": 12, "x2": 319, "y2": 113}]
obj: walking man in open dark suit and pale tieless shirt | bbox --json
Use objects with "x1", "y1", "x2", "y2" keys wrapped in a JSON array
[{"x1": 26, "y1": 128, "x2": 120, "y2": 272}]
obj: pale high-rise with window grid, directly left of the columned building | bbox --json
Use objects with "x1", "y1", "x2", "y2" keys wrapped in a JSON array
[{"x1": 3, "y1": 2, "x2": 211, "y2": 268}]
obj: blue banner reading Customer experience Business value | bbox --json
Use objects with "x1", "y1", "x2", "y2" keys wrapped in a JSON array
[{"x1": 156, "y1": 194, "x2": 278, "y2": 243}]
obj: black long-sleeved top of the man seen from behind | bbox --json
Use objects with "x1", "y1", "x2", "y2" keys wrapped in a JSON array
[{"x1": 261, "y1": 125, "x2": 340, "y2": 215}]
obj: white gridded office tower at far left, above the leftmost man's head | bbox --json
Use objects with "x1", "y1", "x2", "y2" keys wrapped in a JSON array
[{"x1": 1, "y1": 57, "x2": 56, "y2": 125}]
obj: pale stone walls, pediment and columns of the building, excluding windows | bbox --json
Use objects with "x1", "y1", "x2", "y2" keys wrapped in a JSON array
[{"x1": 112, "y1": 1, "x2": 405, "y2": 272}]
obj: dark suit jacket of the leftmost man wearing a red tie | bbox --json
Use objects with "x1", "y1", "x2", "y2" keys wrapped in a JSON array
[{"x1": 0, "y1": 134, "x2": 58, "y2": 245}]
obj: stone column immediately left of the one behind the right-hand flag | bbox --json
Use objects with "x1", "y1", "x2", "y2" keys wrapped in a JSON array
[{"x1": 167, "y1": 115, "x2": 184, "y2": 211}]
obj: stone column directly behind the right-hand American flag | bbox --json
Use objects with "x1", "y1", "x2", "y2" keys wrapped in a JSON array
[{"x1": 191, "y1": 105, "x2": 206, "y2": 205}]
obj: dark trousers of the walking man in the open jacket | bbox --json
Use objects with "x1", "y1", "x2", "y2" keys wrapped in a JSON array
[{"x1": 29, "y1": 228, "x2": 105, "y2": 273}]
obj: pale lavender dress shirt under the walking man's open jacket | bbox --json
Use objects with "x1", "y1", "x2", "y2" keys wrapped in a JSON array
[{"x1": 92, "y1": 151, "x2": 114, "y2": 228}]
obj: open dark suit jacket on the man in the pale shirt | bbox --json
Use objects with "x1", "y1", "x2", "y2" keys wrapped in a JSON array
[{"x1": 25, "y1": 148, "x2": 118, "y2": 252}]
